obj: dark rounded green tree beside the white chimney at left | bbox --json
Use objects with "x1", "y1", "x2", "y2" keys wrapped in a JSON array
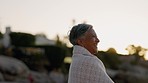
[{"x1": 10, "y1": 32, "x2": 35, "y2": 46}]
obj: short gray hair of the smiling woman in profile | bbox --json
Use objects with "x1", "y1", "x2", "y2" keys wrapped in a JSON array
[{"x1": 69, "y1": 24, "x2": 93, "y2": 45}]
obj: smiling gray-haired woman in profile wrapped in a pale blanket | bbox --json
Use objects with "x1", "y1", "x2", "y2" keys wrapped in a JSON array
[{"x1": 68, "y1": 24, "x2": 114, "y2": 83}]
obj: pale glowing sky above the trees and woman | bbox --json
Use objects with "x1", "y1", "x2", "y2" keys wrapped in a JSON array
[{"x1": 0, "y1": 0, "x2": 148, "y2": 57}]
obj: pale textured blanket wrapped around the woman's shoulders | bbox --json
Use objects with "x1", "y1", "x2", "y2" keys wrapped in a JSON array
[{"x1": 68, "y1": 45, "x2": 114, "y2": 83}]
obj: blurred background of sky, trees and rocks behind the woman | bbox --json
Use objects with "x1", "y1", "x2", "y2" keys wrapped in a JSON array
[{"x1": 0, "y1": 0, "x2": 148, "y2": 83}]
